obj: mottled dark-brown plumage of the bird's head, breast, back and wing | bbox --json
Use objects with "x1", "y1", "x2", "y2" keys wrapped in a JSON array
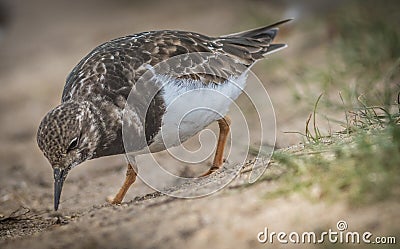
[{"x1": 37, "y1": 20, "x2": 288, "y2": 209}]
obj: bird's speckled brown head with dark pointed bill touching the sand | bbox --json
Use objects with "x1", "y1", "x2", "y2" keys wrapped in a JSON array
[{"x1": 37, "y1": 102, "x2": 99, "y2": 210}]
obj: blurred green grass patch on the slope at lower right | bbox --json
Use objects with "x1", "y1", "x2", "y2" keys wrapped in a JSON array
[{"x1": 268, "y1": 125, "x2": 400, "y2": 205}]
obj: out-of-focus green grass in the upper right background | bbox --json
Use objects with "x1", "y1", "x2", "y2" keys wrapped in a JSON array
[{"x1": 290, "y1": 0, "x2": 400, "y2": 112}]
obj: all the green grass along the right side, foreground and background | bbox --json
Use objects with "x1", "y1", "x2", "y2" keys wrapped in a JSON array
[{"x1": 265, "y1": 0, "x2": 400, "y2": 206}]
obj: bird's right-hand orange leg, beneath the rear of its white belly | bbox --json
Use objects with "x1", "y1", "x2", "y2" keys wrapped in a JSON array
[{"x1": 202, "y1": 116, "x2": 231, "y2": 176}]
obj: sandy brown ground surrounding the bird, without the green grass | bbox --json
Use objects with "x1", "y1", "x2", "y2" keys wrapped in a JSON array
[{"x1": 0, "y1": 0, "x2": 400, "y2": 248}]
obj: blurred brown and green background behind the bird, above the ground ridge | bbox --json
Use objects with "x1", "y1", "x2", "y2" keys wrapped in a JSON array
[{"x1": 0, "y1": 0, "x2": 400, "y2": 246}]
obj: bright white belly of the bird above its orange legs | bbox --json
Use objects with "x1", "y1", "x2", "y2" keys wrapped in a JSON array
[{"x1": 150, "y1": 74, "x2": 247, "y2": 152}]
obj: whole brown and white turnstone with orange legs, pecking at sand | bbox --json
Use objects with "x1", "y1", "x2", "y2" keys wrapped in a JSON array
[{"x1": 37, "y1": 19, "x2": 290, "y2": 210}]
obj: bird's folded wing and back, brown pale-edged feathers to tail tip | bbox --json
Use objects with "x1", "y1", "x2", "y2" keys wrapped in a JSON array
[{"x1": 62, "y1": 20, "x2": 289, "y2": 105}]
